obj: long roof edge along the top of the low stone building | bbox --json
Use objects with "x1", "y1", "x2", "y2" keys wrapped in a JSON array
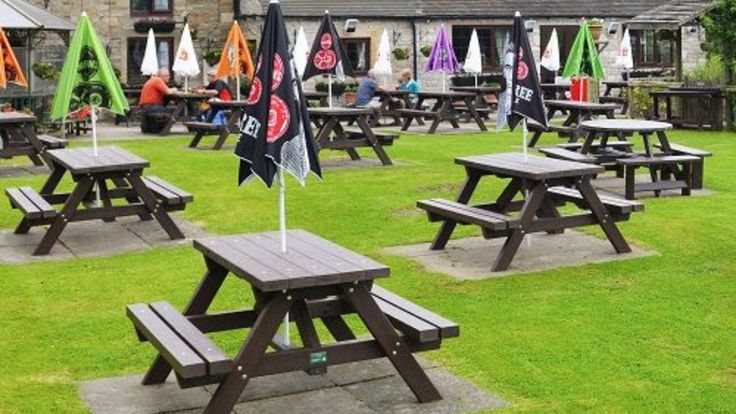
[{"x1": 252, "y1": 0, "x2": 669, "y2": 19}]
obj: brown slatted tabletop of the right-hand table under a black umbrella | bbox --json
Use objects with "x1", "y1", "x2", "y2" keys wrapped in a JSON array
[{"x1": 455, "y1": 152, "x2": 603, "y2": 180}]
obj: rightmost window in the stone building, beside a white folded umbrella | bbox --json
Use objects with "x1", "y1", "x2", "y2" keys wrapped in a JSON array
[{"x1": 630, "y1": 30, "x2": 675, "y2": 68}]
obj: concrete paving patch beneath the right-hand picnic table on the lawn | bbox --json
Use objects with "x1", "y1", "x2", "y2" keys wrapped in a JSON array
[{"x1": 383, "y1": 230, "x2": 656, "y2": 279}]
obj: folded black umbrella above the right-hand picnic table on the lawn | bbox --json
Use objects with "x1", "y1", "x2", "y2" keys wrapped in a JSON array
[{"x1": 499, "y1": 12, "x2": 547, "y2": 131}]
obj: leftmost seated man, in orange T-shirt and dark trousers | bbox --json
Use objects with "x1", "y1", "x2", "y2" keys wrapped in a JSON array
[{"x1": 138, "y1": 69, "x2": 176, "y2": 134}]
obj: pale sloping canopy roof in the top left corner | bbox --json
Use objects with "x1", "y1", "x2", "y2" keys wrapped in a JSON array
[{"x1": 0, "y1": 0, "x2": 75, "y2": 31}]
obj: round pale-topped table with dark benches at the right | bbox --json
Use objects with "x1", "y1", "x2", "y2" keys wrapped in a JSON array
[{"x1": 580, "y1": 119, "x2": 703, "y2": 199}]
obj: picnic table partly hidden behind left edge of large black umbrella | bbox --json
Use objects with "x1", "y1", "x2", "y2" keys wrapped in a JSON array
[{"x1": 184, "y1": 99, "x2": 248, "y2": 150}]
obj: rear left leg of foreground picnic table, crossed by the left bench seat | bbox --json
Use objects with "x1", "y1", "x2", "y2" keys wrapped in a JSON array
[{"x1": 141, "y1": 257, "x2": 228, "y2": 385}]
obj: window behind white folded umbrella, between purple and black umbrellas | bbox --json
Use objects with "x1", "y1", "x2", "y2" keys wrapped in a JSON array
[{"x1": 452, "y1": 26, "x2": 511, "y2": 71}]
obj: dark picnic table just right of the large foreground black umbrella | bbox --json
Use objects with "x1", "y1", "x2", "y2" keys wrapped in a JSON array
[{"x1": 308, "y1": 108, "x2": 398, "y2": 165}]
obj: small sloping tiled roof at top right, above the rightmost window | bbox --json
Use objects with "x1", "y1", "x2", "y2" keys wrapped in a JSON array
[{"x1": 626, "y1": 0, "x2": 715, "y2": 29}]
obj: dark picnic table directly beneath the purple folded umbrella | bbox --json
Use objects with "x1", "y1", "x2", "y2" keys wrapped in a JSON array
[{"x1": 397, "y1": 91, "x2": 488, "y2": 134}]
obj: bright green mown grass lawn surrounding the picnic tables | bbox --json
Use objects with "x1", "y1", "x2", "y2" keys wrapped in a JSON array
[{"x1": 0, "y1": 128, "x2": 736, "y2": 414}]
